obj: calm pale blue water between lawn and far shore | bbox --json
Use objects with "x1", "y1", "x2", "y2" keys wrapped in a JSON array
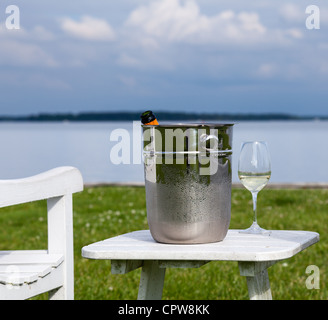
[{"x1": 0, "y1": 121, "x2": 328, "y2": 183}]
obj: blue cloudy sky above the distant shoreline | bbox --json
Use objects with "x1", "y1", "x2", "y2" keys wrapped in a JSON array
[{"x1": 0, "y1": 0, "x2": 328, "y2": 116}]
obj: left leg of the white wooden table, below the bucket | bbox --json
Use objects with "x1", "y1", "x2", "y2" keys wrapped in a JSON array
[{"x1": 138, "y1": 260, "x2": 166, "y2": 300}]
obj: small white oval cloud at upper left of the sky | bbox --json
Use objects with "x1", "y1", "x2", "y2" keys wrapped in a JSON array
[{"x1": 60, "y1": 16, "x2": 115, "y2": 41}]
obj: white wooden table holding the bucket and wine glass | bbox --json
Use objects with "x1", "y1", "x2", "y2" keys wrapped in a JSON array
[{"x1": 82, "y1": 230, "x2": 319, "y2": 300}]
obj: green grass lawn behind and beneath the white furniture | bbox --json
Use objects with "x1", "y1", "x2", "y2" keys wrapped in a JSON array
[{"x1": 0, "y1": 187, "x2": 328, "y2": 300}]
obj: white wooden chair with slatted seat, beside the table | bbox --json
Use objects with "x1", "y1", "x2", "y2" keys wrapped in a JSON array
[{"x1": 0, "y1": 167, "x2": 83, "y2": 300}]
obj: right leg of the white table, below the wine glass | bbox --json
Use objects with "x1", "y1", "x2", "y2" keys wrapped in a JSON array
[{"x1": 238, "y1": 261, "x2": 275, "y2": 300}]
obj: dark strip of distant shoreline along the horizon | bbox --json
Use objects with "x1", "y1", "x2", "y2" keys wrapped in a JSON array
[{"x1": 0, "y1": 111, "x2": 328, "y2": 122}]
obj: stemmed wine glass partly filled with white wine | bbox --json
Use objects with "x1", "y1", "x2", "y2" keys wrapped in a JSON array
[{"x1": 238, "y1": 141, "x2": 271, "y2": 234}]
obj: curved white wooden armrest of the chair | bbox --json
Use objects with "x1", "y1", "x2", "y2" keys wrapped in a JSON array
[{"x1": 0, "y1": 167, "x2": 83, "y2": 207}]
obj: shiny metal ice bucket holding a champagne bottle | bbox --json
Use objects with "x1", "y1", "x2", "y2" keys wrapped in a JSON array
[{"x1": 143, "y1": 124, "x2": 233, "y2": 244}]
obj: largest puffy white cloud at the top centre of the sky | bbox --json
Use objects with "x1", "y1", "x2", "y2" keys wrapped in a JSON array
[{"x1": 126, "y1": 0, "x2": 266, "y2": 44}]
